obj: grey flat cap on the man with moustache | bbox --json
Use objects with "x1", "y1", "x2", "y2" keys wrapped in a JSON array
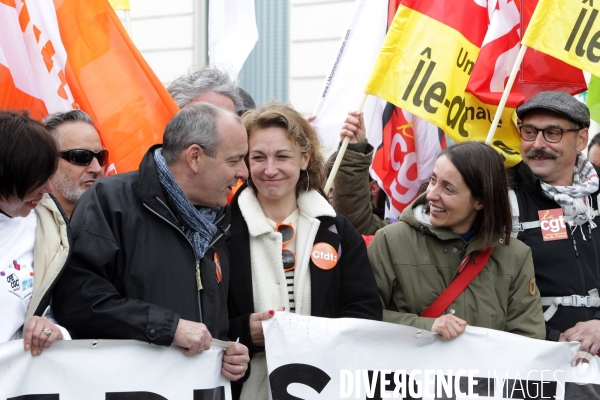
[{"x1": 517, "y1": 92, "x2": 590, "y2": 128}]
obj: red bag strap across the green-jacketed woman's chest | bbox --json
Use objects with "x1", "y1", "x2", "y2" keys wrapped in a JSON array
[{"x1": 421, "y1": 247, "x2": 494, "y2": 318}]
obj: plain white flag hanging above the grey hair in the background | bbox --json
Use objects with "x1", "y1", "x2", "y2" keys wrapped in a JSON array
[{"x1": 208, "y1": 0, "x2": 258, "y2": 80}]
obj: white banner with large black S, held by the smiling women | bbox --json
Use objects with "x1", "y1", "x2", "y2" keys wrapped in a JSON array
[{"x1": 263, "y1": 313, "x2": 600, "y2": 400}]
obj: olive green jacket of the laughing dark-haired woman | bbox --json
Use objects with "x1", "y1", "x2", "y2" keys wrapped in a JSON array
[{"x1": 367, "y1": 195, "x2": 546, "y2": 339}]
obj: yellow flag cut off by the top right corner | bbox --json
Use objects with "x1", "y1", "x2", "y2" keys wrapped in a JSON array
[{"x1": 522, "y1": 0, "x2": 600, "y2": 75}]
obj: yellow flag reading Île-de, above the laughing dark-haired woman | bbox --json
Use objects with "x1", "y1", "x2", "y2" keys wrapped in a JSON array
[{"x1": 365, "y1": 2, "x2": 521, "y2": 166}]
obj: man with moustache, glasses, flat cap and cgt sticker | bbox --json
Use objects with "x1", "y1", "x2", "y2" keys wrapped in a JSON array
[{"x1": 508, "y1": 92, "x2": 600, "y2": 360}]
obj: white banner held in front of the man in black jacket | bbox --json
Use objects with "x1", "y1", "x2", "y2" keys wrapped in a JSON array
[{"x1": 0, "y1": 340, "x2": 231, "y2": 400}]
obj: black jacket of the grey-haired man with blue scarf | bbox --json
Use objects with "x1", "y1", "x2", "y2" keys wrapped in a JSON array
[{"x1": 52, "y1": 146, "x2": 229, "y2": 346}]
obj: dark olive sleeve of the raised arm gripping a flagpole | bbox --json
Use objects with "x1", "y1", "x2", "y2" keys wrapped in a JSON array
[{"x1": 333, "y1": 142, "x2": 389, "y2": 235}]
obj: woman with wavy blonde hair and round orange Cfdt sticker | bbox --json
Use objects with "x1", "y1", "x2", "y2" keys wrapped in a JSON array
[{"x1": 227, "y1": 103, "x2": 382, "y2": 399}]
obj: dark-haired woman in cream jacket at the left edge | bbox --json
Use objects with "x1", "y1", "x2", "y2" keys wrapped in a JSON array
[{"x1": 0, "y1": 111, "x2": 69, "y2": 356}]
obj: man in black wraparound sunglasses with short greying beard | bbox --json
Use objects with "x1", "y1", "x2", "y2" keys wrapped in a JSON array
[{"x1": 43, "y1": 110, "x2": 108, "y2": 218}]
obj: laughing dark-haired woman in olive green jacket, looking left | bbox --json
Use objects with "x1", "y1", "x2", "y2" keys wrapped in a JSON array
[{"x1": 368, "y1": 142, "x2": 545, "y2": 339}]
